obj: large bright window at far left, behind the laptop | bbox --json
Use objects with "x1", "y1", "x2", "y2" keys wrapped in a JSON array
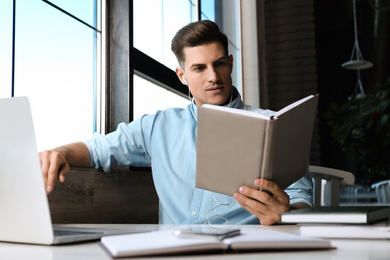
[{"x1": 0, "y1": 0, "x2": 100, "y2": 150}]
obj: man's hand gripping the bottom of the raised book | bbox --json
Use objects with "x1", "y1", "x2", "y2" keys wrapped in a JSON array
[{"x1": 234, "y1": 179, "x2": 290, "y2": 225}]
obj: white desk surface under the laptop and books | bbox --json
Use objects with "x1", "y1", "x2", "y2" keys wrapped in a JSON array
[{"x1": 0, "y1": 224, "x2": 390, "y2": 260}]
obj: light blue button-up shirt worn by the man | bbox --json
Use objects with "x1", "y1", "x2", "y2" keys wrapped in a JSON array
[{"x1": 85, "y1": 89, "x2": 312, "y2": 224}]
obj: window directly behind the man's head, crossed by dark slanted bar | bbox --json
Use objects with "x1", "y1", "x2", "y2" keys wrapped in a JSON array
[{"x1": 130, "y1": 0, "x2": 241, "y2": 118}]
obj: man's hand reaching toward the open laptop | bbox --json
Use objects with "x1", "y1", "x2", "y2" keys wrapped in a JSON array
[{"x1": 39, "y1": 150, "x2": 69, "y2": 194}]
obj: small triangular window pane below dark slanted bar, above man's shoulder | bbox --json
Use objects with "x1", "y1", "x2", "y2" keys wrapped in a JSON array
[{"x1": 134, "y1": 75, "x2": 190, "y2": 119}]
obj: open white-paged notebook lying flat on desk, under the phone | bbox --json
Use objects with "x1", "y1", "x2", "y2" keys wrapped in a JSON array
[{"x1": 100, "y1": 229, "x2": 331, "y2": 258}]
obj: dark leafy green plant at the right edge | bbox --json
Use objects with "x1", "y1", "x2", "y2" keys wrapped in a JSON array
[{"x1": 324, "y1": 84, "x2": 390, "y2": 184}]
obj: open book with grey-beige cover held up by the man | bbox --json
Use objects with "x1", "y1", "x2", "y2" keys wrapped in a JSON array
[{"x1": 196, "y1": 95, "x2": 318, "y2": 196}]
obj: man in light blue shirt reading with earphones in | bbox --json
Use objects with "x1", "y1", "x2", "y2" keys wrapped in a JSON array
[{"x1": 40, "y1": 21, "x2": 312, "y2": 225}]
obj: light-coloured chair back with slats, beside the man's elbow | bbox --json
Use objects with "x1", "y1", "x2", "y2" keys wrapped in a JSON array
[{"x1": 309, "y1": 165, "x2": 355, "y2": 206}]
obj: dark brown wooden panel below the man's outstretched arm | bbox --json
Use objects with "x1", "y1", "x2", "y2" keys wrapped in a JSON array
[{"x1": 48, "y1": 168, "x2": 158, "y2": 224}]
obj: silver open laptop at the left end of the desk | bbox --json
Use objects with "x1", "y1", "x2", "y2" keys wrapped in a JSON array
[{"x1": 0, "y1": 97, "x2": 143, "y2": 245}]
